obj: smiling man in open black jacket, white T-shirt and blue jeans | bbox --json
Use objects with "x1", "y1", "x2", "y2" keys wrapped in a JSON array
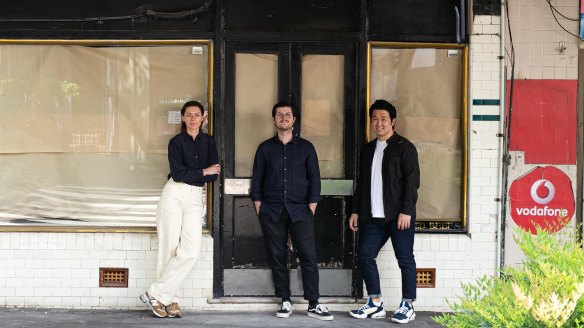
[{"x1": 349, "y1": 99, "x2": 420, "y2": 323}]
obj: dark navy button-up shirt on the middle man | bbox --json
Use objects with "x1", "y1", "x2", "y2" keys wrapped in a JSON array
[{"x1": 250, "y1": 135, "x2": 321, "y2": 222}]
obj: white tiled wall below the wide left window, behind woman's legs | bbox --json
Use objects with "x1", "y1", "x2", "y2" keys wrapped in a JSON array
[{"x1": 0, "y1": 232, "x2": 213, "y2": 308}]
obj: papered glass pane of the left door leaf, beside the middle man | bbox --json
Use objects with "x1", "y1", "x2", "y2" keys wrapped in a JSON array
[{"x1": 235, "y1": 53, "x2": 278, "y2": 177}]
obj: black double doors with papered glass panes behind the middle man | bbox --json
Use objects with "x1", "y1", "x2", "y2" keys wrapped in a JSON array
[{"x1": 221, "y1": 42, "x2": 357, "y2": 297}]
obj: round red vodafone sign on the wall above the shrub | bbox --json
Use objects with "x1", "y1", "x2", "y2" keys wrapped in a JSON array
[{"x1": 509, "y1": 166, "x2": 574, "y2": 234}]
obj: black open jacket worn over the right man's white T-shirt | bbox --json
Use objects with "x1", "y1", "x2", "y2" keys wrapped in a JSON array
[{"x1": 352, "y1": 133, "x2": 420, "y2": 223}]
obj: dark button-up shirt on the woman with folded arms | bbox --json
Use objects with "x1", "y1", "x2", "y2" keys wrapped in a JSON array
[{"x1": 168, "y1": 132, "x2": 219, "y2": 187}]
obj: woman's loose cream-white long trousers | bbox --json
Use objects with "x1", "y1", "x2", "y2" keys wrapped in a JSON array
[{"x1": 148, "y1": 178, "x2": 203, "y2": 306}]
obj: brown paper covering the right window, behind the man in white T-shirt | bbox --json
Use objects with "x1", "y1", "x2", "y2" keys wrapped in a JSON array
[{"x1": 370, "y1": 48, "x2": 463, "y2": 221}]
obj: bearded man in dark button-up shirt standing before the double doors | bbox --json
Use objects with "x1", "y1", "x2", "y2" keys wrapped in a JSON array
[{"x1": 250, "y1": 103, "x2": 333, "y2": 320}]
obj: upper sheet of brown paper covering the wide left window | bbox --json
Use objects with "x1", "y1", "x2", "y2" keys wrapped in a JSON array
[{"x1": 0, "y1": 45, "x2": 208, "y2": 153}]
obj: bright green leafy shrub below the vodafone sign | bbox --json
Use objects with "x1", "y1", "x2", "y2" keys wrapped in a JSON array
[{"x1": 433, "y1": 228, "x2": 584, "y2": 328}]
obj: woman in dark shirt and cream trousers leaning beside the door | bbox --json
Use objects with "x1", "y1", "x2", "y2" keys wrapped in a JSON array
[{"x1": 140, "y1": 101, "x2": 221, "y2": 318}]
